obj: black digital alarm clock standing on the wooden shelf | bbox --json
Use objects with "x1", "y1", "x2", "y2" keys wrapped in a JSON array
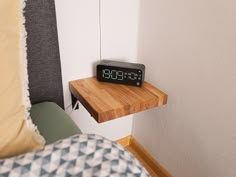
[{"x1": 97, "y1": 60, "x2": 145, "y2": 87}]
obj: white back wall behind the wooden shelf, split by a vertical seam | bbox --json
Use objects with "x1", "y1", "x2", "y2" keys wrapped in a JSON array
[{"x1": 55, "y1": 0, "x2": 138, "y2": 140}]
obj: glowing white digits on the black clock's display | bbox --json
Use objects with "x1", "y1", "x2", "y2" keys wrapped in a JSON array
[{"x1": 102, "y1": 69, "x2": 138, "y2": 80}]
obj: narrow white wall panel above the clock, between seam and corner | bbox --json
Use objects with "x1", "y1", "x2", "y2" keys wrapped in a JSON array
[{"x1": 101, "y1": 0, "x2": 139, "y2": 62}]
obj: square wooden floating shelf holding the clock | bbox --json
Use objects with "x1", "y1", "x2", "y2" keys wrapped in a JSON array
[{"x1": 69, "y1": 77, "x2": 167, "y2": 123}]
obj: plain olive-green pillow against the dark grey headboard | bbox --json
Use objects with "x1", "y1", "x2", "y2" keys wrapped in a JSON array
[{"x1": 30, "y1": 102, "x2": 81, "y2": 144}]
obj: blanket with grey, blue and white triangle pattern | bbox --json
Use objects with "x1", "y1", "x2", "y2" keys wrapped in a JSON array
[{"x1": 0, "y1": 134, "x2": 150, "y2": 177}]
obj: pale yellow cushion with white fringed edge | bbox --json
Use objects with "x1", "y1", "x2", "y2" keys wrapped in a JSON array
[{"x1": 0, "y1": 0, "x2": 45, "y2": 158}]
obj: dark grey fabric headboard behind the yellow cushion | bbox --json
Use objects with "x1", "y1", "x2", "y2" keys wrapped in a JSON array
[{"x1": 24, "y1": 0, "x2": 64, "y2": 108}]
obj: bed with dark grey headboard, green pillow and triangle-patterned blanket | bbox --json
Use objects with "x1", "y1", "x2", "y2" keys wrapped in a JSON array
[{"x1": 0, "y1": 0, "x2": 149, "y2": 177}]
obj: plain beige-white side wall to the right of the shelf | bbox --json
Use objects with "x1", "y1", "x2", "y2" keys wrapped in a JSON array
[{"x1": 133, "y1": 0, "x2": 236, "y2": 177}]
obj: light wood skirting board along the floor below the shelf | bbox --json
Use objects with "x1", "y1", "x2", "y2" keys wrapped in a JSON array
[{"x1": 116, "y1": 135, "x2": 172, "y2": 177}]
